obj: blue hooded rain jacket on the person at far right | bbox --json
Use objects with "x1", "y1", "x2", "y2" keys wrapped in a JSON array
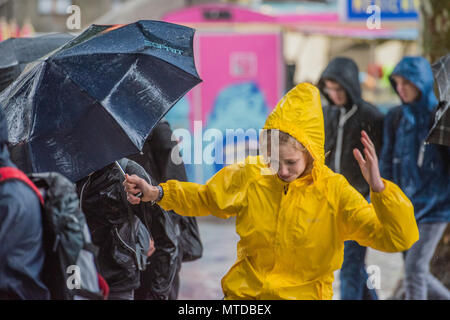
[{"x1": 380, "y1": 57, "x2": 450, "y2": 223}]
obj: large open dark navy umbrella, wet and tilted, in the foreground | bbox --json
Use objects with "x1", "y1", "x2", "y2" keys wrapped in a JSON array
[{"x1": 0, "y1": 21, "x2": 201, "y2": 181}]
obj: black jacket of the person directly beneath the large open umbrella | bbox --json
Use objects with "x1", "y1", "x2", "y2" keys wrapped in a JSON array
[{"x1": 77, "y1": 160, "x2": 151, "y2": 292}]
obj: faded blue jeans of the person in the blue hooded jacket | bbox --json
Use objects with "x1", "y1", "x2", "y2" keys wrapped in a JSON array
[{"x1": 403, "y1": 222, "x2": 450, "y2": 300}]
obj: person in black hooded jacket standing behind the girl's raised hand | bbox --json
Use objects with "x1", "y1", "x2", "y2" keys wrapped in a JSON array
[{"x1": 318, "y1": 57, "x2": 383, "y2": 300}]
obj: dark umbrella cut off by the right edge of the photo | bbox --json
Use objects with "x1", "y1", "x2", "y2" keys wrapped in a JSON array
[{"x1": 426, "y1": 53, "x2": 450, "y2": 146}]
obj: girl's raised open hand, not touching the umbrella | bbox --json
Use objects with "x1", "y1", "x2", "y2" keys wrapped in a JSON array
[{"x1": 353, "y1": 130, "x2": 384, "y2": 192}]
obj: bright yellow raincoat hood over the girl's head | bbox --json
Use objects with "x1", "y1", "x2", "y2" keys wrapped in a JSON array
[{"x1": 263, "y1": 83, "x2": 325, "y2": 175}]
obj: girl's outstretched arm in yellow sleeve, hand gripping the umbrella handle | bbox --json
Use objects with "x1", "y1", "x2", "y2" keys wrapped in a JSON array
[{"x1": 124, "y1": 164, "x2": 246, "y2": 218}]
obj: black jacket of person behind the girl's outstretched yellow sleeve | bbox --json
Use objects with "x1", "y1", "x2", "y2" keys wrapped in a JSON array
[{"x1": 129, "y1": 119, "x2": 202, "y2": 300}]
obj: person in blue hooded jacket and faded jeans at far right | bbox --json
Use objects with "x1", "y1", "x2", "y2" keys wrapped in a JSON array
[{"x1": 380, "y1": 57, "x2": 450, "y2": 299}]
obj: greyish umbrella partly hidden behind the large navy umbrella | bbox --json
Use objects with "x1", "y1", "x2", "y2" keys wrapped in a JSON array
[{"x1": 0, "y1": 33, "x2": 74, "y2": 91}]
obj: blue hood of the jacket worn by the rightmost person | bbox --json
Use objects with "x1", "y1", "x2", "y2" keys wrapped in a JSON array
[{"x1": 389, "y1": 57, "x2": 438, "y2": 112}]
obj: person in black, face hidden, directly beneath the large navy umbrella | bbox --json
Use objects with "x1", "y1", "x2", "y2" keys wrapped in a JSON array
[{"x1": 77, "y1": 158, "x2": 154, "y2": 300}]
